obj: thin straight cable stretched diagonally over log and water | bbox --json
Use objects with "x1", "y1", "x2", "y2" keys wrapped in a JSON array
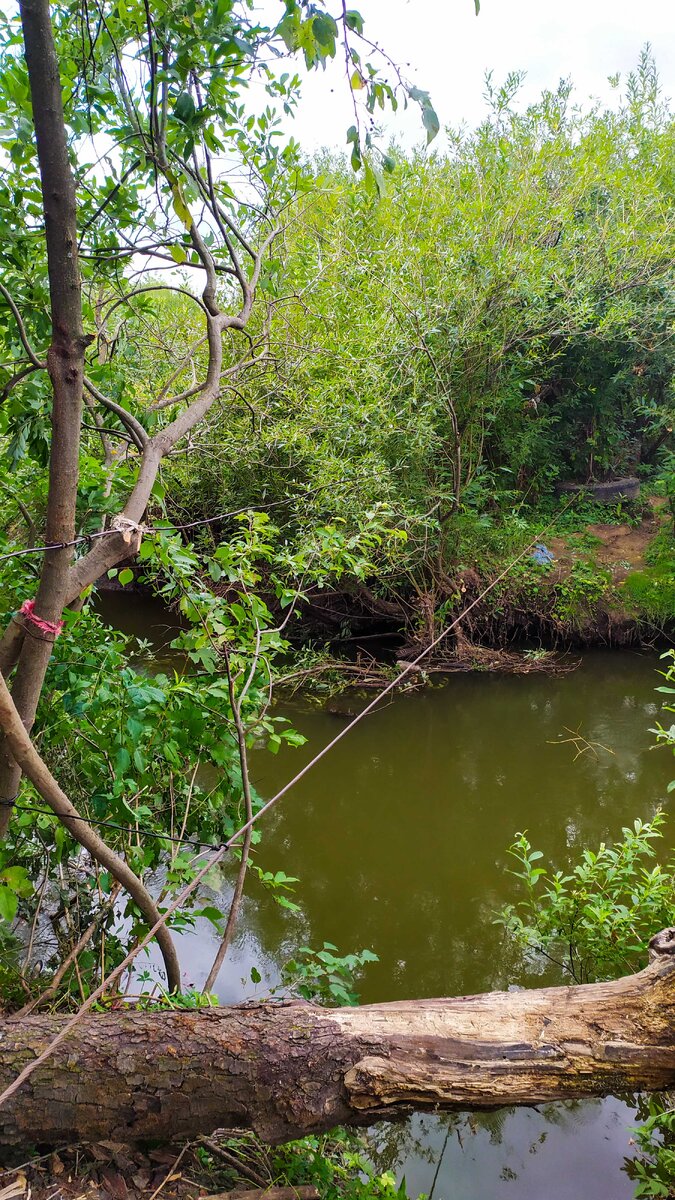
[{"x1": 0, "y1": 497, "x2": 577, "y2": 1108}]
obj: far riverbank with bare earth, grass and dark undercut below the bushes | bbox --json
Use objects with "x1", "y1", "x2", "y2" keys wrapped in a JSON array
[{"x1": 100, "y1": 499, "x2": 675, "y2": 691}]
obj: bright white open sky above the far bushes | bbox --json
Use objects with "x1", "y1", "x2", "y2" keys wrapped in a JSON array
[{"x1": 276, "y1": 0, "x2": 675, "y2": 151}]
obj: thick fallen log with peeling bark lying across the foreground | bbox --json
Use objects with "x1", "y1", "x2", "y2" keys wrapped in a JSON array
[{"x1": 0, "y1": 929, "x2": 675, "y2": 1154}]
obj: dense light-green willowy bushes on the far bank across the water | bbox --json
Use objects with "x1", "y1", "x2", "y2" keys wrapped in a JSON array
[{"x1": 162, "y1": 55, "x2": 675, "y2": 619}]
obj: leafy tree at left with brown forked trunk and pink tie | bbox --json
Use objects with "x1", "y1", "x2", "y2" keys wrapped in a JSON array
[{"x1": 0, "y1": 0, "x2": 437, "y2": 990}]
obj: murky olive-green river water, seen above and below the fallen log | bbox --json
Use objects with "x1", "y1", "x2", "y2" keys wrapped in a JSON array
[{"x1": 99, "y1": 592, "x2": 675, "y2": 1200}]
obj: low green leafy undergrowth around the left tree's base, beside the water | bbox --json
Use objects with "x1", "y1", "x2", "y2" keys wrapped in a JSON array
[{"x1": 0, "y1": 501, "x2": 398, "y2": 1002}]
